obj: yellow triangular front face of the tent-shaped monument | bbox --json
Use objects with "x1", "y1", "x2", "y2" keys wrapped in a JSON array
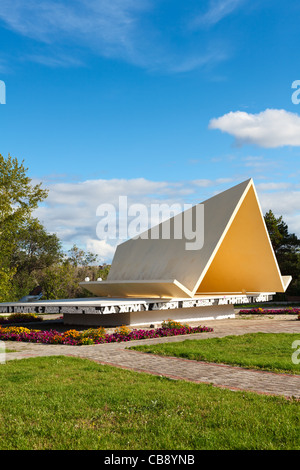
[{"x1": 196, "y1": 183, "x2": 285, "y2": 294}]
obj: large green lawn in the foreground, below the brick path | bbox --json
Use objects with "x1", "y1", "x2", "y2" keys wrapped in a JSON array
[{"x1": 0, "y1": 357, "x2": 300, "y2": 450}]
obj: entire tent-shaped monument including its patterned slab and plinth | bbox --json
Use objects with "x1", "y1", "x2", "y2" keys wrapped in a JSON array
[{"x1": 0, "y1": 179, "x2": 291, "y2": 326}]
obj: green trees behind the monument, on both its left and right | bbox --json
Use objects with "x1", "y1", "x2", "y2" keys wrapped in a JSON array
[{"x1": 0, "y1": 154, "x2": 300, "y2": 302}]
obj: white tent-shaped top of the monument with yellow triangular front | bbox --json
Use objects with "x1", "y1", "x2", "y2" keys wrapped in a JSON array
[{"x1": 81, "y1": 179, "x2": 291, "y2": 299}]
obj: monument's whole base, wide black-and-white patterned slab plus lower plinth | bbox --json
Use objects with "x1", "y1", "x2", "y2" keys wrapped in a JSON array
[{"x1": 0, "y1": 293, "x2": 274, "y2": 326}]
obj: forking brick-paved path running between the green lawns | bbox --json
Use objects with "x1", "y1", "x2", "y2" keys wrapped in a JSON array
[{"x1": 2, "y1": 316, "x2": 300, "y2": 399}]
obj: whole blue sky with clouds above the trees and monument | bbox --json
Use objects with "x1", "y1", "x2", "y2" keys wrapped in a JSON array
[{"x1": 0, "y1": 0, "x2": 300, "y2": 261}]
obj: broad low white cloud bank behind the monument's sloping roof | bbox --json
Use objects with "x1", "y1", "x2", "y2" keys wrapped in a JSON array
[{"x1": 32, "y1": 178, "x2": 244, "y2": 262}]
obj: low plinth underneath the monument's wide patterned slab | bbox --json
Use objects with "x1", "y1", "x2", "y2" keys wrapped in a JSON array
[{"x1": 64, "y1": 305, "x2": 235, "y2": 327}]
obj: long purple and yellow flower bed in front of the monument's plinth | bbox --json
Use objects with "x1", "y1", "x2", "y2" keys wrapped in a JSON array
[{"x1": 0, "y1": 325, "x2": 213, "y2": 346}]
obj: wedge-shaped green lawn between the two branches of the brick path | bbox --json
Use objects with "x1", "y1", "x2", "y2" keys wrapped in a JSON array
[{"x1": 132, "y1": 333, "x2": 300, "y2": 374}]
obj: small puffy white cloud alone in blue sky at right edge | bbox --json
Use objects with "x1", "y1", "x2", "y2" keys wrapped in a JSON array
[{"x1": 209, "y1": 109, "x2": 300, "y2": 148}]
